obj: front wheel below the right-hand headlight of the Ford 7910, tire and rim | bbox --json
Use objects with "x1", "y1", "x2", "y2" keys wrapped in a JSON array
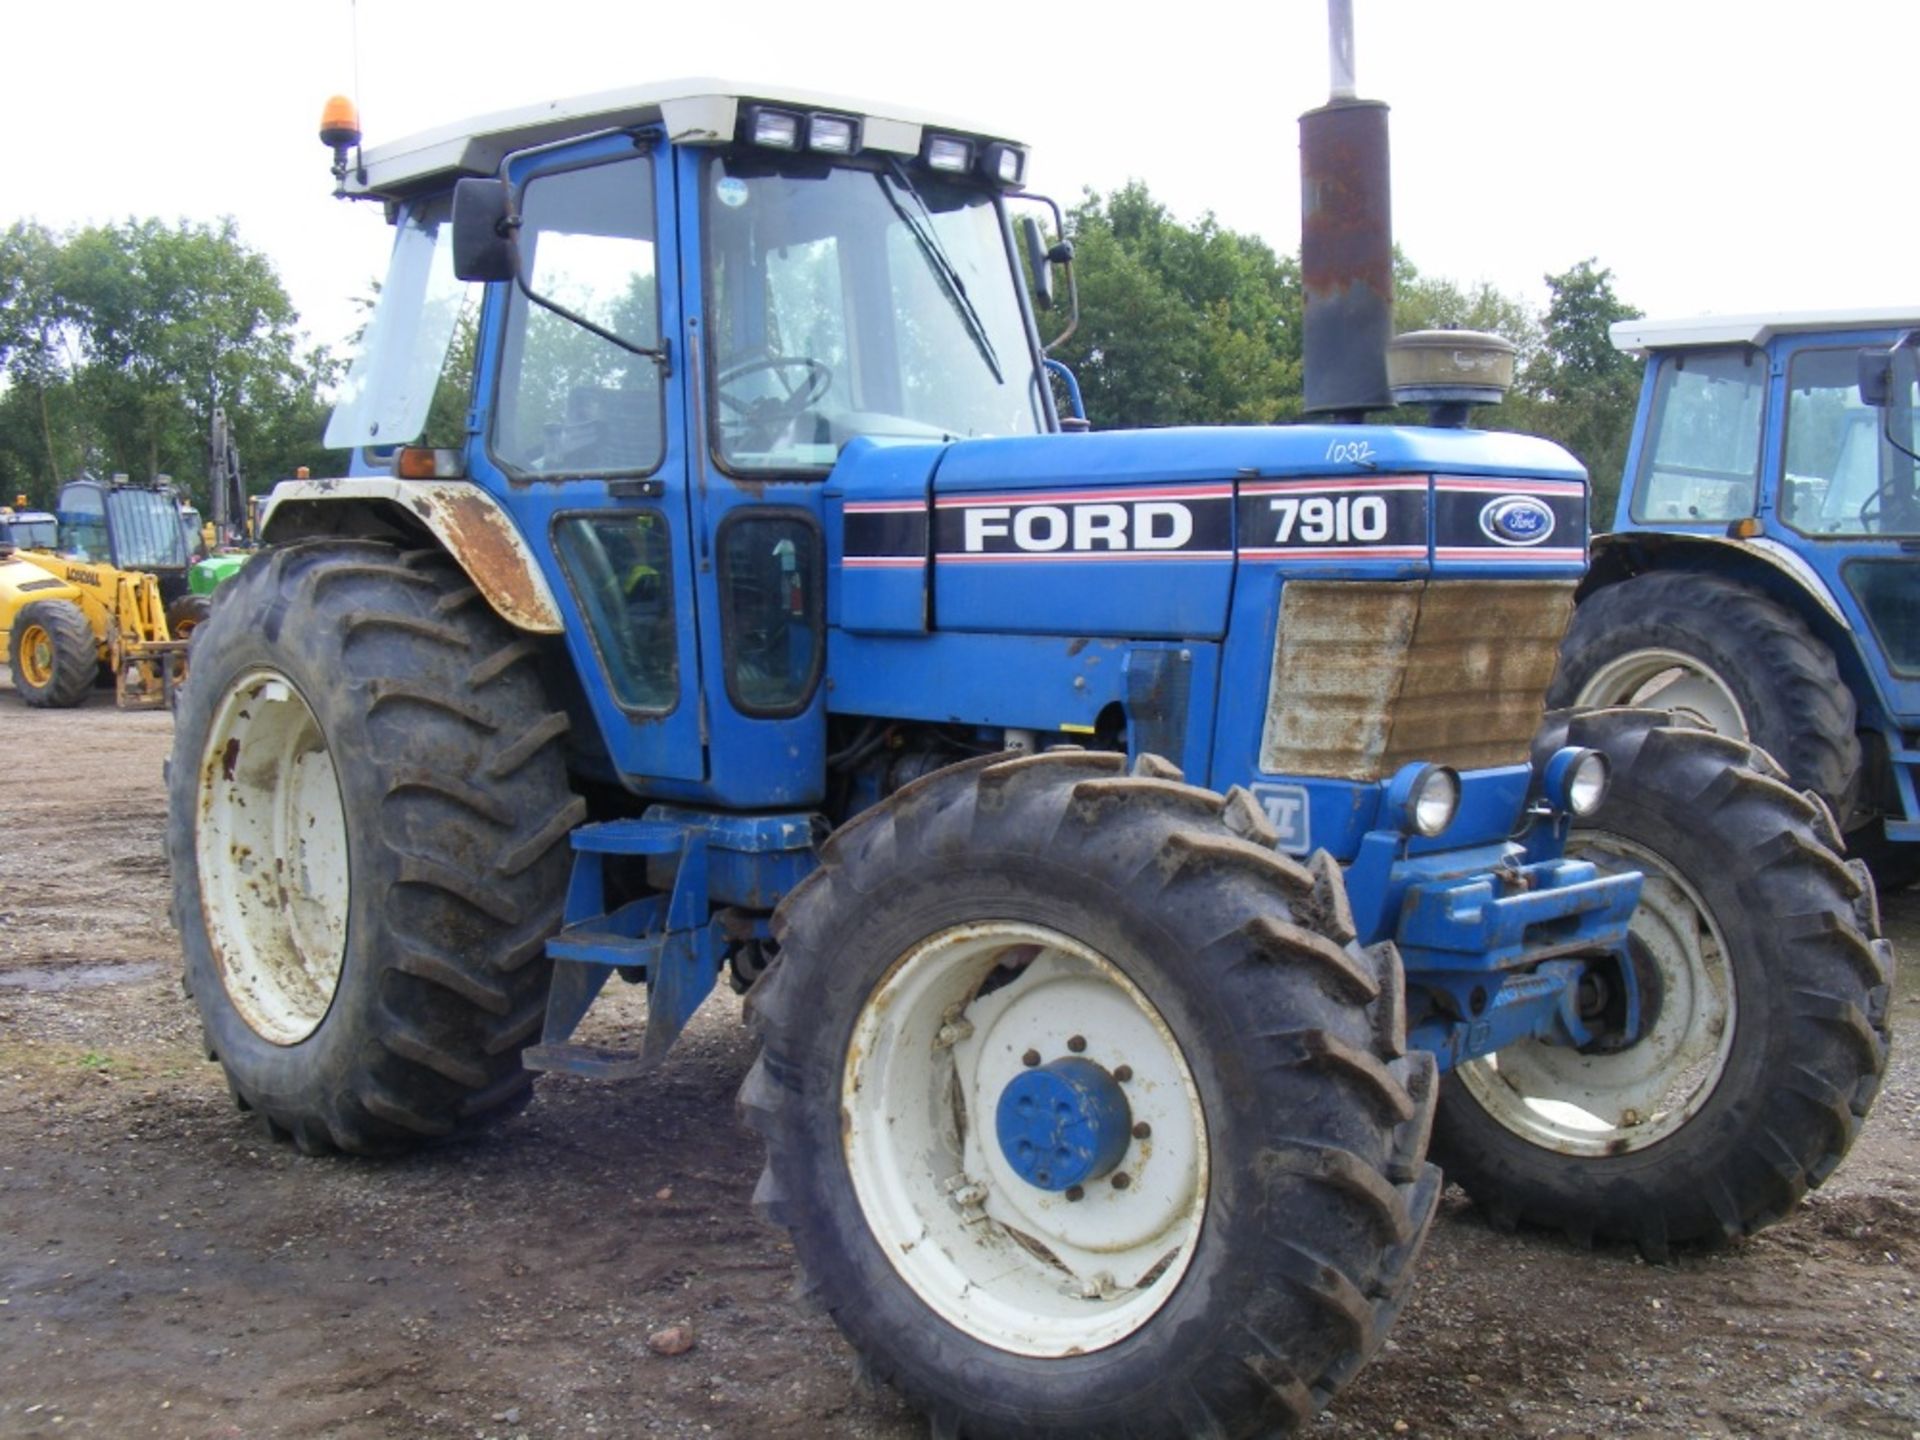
[{"x1": 1434, "y1": 710, "x2": 1893, "y2": 1256}]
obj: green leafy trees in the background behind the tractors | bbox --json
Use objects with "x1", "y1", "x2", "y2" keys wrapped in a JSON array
[{"x1": 0, "y1": 182, "x2": 1640, "y2": 524}]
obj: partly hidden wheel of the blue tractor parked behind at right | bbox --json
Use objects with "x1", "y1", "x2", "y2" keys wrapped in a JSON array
[{"x1": 1548, "y1": 570, "x2": 1860, "y2": 826}]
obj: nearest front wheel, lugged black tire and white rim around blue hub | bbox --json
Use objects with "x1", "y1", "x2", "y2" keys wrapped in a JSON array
[{"x1": 741, "y1": 753, "x2": 1438, "y2": 1440}]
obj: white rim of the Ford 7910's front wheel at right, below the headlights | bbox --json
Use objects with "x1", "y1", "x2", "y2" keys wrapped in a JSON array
[{"x1": 1455, "y1": 835, "x2": 1736, "y2": 1156}]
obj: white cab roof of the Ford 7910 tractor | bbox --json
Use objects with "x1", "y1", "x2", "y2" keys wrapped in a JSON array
[{"x1": 348, "y1": 77, "x2": 1010, "y2": 198}]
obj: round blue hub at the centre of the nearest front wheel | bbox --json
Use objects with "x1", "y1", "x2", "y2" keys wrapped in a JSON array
[{"x1": 995, "y1": 1056, "x2": 1133, "y2": 1190}]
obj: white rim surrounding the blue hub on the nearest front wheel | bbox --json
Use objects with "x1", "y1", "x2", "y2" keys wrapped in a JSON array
[{"x1": 841, "y1": 922, "x2": 1208, "y2": 1357}]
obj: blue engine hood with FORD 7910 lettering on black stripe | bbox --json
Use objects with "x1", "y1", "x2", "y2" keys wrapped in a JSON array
[{"x1": 826, "y1": 426, "x2": 1586, "y2": 639}]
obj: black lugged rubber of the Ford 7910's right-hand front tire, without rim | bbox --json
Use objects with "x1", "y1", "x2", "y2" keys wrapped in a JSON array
[{"x1": 1434, "y1": 708, "x2": 1893, "y2": 1260}]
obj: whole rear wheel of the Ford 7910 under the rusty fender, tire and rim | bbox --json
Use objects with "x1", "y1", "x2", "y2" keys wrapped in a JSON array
[{"x1": 167, "y1": 540, "x2": 584, "y2": 1154}]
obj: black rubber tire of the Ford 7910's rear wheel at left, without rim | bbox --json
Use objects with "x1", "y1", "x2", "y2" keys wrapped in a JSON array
[{"x1": 171, "y1": 540, "x2": 586, "y2": 1154}]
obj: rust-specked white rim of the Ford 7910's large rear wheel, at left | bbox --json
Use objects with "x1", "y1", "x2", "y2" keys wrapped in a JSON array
[{"x1": 194, "y1": 668, "x2": 348, "y2": 1044}]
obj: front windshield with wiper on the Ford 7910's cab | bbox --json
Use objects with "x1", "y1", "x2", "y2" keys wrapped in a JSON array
[{"x1": 705, "y1": 156, "x2": 1046, "y2": 472}]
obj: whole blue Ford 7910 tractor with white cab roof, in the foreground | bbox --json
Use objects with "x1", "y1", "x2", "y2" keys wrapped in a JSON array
[{"x1": 169, "y1": 81, "x2": 1891, "y2": 1438}]
